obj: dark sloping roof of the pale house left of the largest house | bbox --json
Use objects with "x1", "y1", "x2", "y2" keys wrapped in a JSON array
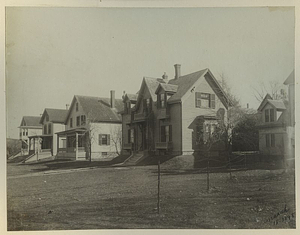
[{"x1": 75, "y1": 95, "x2": 124, "y2": 122}]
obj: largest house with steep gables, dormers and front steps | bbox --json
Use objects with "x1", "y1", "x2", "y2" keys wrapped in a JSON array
[{"x1": 122, "y1": 64, "x2": 232, "y2": 163}]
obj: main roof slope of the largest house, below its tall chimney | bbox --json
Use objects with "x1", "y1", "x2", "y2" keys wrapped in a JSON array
[{"x1": 168, "y1": 69, "x2": 208, "y2": 102}]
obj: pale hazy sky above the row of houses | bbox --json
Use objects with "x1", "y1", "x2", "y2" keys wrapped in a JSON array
[{"x1": 5, "y1": 7, "x2": 295, "y2": 138}]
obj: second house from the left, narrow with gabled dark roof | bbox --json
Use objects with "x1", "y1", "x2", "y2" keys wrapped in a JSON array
[{"x1": 29, "y1": 108, "x2": 68, "y2": 158}]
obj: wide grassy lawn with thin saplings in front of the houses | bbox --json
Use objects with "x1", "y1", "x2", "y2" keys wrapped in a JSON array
[{"x1": 7, "y1": 164, "x2": 296, "y2": 230}]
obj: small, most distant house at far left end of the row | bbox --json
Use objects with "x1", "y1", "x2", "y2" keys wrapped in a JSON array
[{"x1": 19, "y1": 116, "x2": 42, "y2": 155}]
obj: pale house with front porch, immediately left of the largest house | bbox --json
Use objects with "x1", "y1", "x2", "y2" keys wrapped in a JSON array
[{"x1": 56, "y1": 91, "x2": 123, "y2": 160}]
